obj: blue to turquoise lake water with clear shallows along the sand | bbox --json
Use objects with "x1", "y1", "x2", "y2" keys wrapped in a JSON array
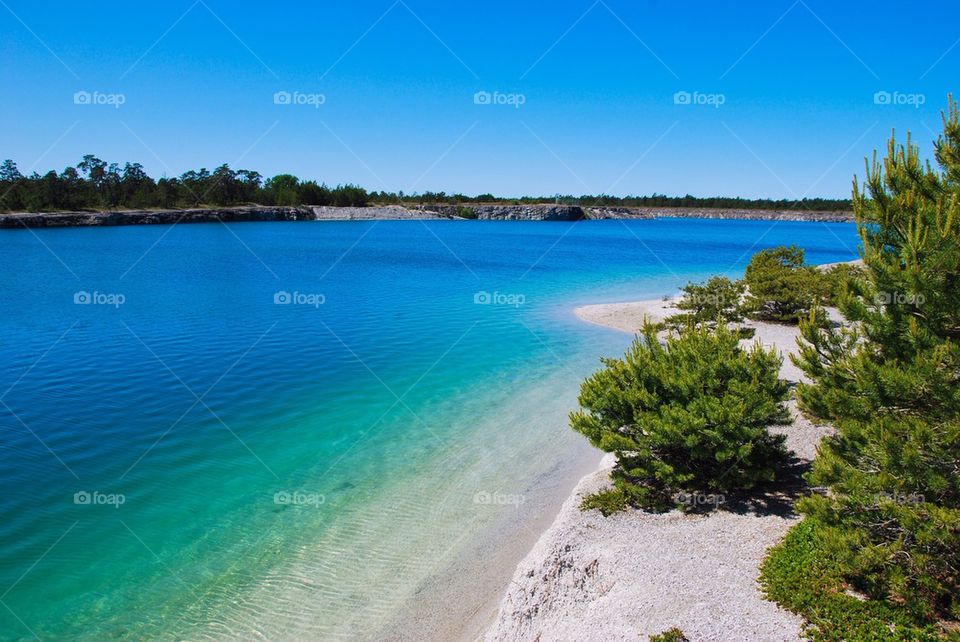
[{"x1": 0, "y1": 219, "x2": 856, "y2": 640}]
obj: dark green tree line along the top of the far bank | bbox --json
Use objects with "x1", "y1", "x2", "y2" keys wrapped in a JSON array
[{"x1": 0, "y1": 154, "x2": 850, "y2": 212}]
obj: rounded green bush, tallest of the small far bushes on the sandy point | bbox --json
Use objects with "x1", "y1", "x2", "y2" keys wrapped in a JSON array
[{"x1": 744, "y1": 245, "x2": 822, "y2": 323}]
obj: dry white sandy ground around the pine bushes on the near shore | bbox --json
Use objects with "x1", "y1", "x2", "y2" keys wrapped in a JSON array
[{"x1": 485, "y1": 300, "x2": 829, "y2": 642}]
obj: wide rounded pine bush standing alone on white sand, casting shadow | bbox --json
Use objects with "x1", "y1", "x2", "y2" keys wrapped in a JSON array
[{"x1": 570, "y1": 323, "x2": 789, "y2": 511}]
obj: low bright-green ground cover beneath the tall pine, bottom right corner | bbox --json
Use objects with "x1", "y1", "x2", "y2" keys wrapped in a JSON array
[{"x1": 760, "y1": 517, "x2": 957, "y2": 642}]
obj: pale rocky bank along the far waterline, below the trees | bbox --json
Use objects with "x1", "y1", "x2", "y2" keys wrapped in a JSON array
[{"x1": 0, "y1": 204, "x2": 853, "y2": 228}]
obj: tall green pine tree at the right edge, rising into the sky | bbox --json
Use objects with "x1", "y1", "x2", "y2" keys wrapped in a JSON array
[{"x1": 795, "y1": 97, "x2": 960, "y2": 621}]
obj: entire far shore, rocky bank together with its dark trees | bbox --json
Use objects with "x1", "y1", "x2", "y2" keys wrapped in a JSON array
[{"x1": 0, "y1": 154, "x2": 853, "y2": 228}]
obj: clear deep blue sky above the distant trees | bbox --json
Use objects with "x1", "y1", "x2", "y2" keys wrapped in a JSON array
[{"x1": 0, "y1": 0, "x2": 960, "y2": 199}]
